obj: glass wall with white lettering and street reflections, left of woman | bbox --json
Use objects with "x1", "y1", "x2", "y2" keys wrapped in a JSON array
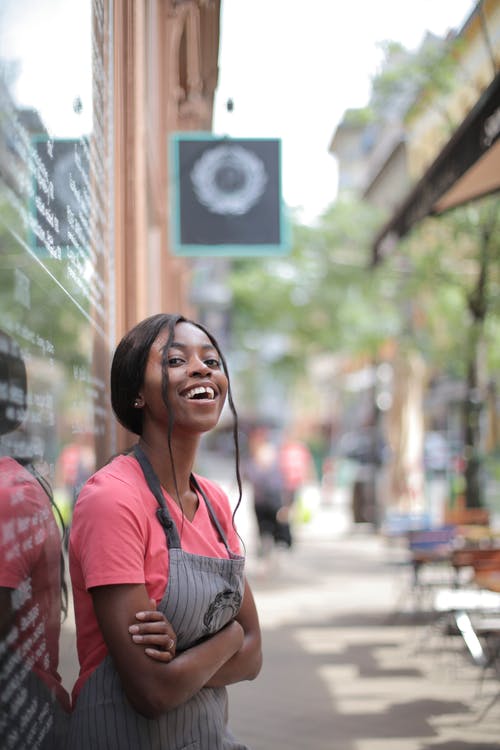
[{"x1": 0, "y1": 0, "x2": 114, "y2": 750}]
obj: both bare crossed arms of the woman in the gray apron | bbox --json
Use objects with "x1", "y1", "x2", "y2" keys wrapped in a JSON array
[{"x1": 90, "y1": 581, "x2": 262, "y2": 718}]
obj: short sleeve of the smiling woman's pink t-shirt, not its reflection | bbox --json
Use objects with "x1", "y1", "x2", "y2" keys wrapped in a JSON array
[{"x1": 71, "y1": 474, "x2": 148, "y2": 590}]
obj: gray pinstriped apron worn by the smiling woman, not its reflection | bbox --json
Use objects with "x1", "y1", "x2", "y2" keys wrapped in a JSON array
[{"x1": 67, "y1": 446, "x2": 248, "y2": 750}]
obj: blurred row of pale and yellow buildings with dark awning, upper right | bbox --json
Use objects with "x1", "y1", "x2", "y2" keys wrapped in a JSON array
[{"x1": 330, "y1": 0, "x2": 500, "y2": 260}]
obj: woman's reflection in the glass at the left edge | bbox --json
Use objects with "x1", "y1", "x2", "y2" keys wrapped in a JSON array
[{"x1": 0, "y1": 331, "x2": 69, "y2": 750}]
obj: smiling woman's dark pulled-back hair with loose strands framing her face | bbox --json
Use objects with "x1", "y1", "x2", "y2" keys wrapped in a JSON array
[{"x1": 111, "y1": 313, "x2": 242, "y2": 511}]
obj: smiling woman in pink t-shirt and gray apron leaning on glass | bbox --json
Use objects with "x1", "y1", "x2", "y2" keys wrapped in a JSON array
[{"x1": 68, "y1": 314, "x2": 262, "y2": 750}]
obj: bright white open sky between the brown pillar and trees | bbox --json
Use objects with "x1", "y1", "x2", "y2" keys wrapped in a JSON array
[{"x1": 213, "y1": 0, "x2": 476, "y2": 223}]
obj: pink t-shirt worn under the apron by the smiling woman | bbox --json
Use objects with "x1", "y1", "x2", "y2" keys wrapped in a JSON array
[{"x1": 69, "y1": 456, "x2": 240, "y2": 701}]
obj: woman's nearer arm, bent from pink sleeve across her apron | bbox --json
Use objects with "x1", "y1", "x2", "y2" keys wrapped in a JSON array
[{"x1": 90, "y1": 584, "x2": 244, "y2": 718}]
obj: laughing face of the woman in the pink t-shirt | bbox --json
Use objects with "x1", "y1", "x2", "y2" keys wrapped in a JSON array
[{"x1": 139, "y1": 322, "x2": 228, "y2": 433}]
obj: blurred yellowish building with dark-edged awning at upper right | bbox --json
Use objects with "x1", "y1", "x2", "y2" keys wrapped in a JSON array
[{"x1": 376, "y1": 0, "x2": 500, "y2": 261}]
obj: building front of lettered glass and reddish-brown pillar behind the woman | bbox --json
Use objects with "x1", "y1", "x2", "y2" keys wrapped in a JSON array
[{"x1": 0, "y1": 0, "x2": 220, "y2": 748}]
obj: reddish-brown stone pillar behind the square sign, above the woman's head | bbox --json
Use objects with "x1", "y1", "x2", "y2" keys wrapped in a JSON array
[{"x1": 113, "y1": 0, "x2": 220, "y2": 335}]
